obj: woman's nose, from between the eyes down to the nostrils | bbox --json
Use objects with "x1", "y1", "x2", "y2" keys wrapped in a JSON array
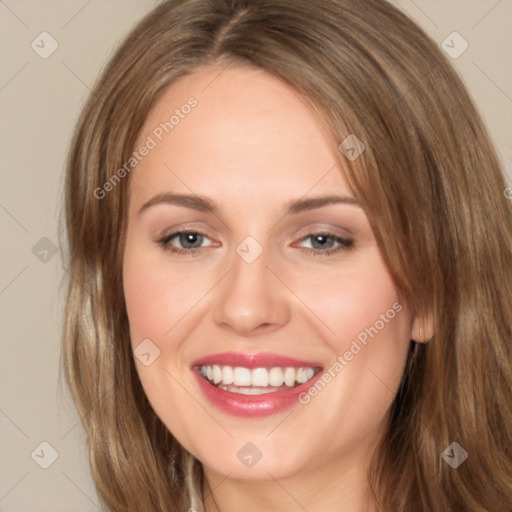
[{"x1": 213, "y1": 247, "x2": 290, "y2": 337}]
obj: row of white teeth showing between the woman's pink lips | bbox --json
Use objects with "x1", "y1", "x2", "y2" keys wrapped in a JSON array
[{"x1": 198, "y1": 364, "x2": 320, "y2": 395}]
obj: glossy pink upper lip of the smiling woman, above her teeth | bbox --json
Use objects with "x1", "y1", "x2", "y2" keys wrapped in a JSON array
[{"x1": 192, "y1": 352, "x2": 322, "y2": 368}]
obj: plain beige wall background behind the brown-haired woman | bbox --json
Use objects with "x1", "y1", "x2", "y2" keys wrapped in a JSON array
[{"x1": 0, "y1": 0, "x2": 512, "y2": 512}]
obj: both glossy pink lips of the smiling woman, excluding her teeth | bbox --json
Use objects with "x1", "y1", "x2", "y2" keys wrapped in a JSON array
[{"x1": 192, "y1": 352, "x2": 323, "y2": 418}]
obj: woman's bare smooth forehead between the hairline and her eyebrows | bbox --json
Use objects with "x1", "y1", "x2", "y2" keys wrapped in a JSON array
[{"x1": 131, "y1": 67, "x2": 350, "y2": 206}]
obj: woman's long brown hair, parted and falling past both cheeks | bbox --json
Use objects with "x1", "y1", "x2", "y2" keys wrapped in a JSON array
[{"x1": 62, "y1": 0, "x2": 512, "y2": 512}]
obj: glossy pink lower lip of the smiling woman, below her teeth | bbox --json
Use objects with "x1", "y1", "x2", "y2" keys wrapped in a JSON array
[{"x1": 194, "y1": 368, "x2": 322, "y2": 418}]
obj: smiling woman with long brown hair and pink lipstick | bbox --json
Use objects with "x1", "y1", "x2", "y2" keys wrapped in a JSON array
[{"x1": 63, "y1": 0, "x2": 512, "y2": 512}]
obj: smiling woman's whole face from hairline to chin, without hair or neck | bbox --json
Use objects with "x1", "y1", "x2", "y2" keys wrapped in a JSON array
[{"x1": 123, "y1": 67, "x2": 415, "y2": 480}]
